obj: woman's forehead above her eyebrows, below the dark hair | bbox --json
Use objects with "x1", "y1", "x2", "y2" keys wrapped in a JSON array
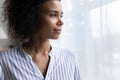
[{"x1": 41, "y1": 0, "x2": 62, "y2": 11}]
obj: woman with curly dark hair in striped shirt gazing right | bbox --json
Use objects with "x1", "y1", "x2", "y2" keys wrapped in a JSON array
[{"x1": 0, "y1": 0, "x2": 80, "y2": 80}]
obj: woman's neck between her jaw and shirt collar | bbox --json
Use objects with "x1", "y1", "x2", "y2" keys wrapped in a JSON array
[{"x1": 23, "y1": 40, "x2": 51, "y2": 55}]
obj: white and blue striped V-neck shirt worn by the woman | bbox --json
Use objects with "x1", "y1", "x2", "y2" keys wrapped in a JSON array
[{"x1": 0, "y1": 47, "x2": 80, "y2": 80}]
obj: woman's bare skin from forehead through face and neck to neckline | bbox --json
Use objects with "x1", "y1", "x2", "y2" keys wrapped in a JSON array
[{"x1": 23, "y1": 0, "x2": 63, "y2": 77}]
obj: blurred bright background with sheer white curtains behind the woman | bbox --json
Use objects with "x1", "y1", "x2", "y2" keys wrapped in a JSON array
[{"x1": 0, "y1": 0, "x2": 120, "y2": 80}]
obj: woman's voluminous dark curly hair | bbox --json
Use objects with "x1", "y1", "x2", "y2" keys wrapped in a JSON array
[{"x1": 3, "y1": 0, "x2": 60, "y2": 42}]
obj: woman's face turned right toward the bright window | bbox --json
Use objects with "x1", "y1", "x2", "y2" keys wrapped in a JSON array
[{"x1": 37, "y1": 0, "x2": 63, "y2": 39}]
